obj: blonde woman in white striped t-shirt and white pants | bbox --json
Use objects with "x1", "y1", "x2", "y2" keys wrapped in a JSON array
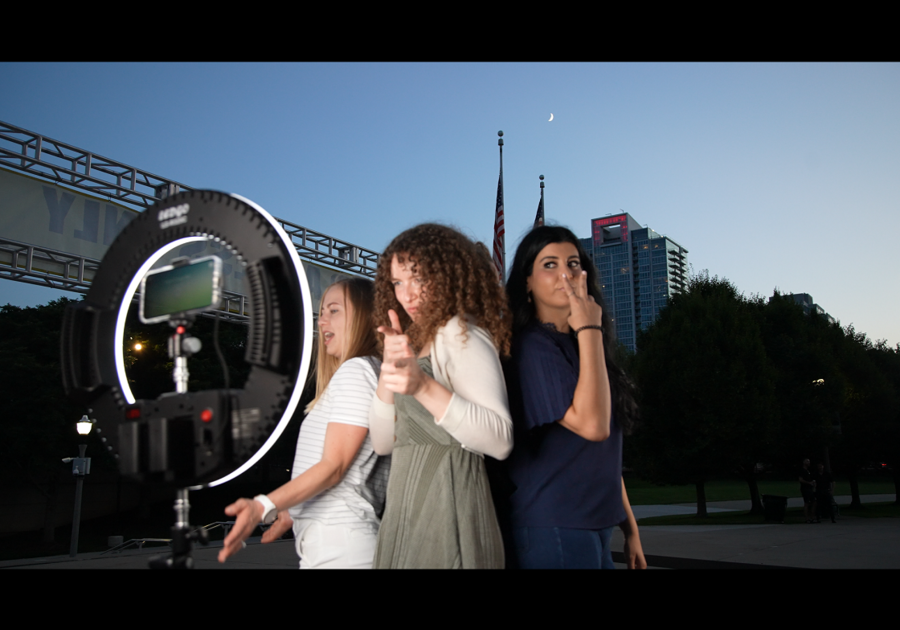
[{"x1": 219, "y1": 278, "x2": 390, "y2": 569}]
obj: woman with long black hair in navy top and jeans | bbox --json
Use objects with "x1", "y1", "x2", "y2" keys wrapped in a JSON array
[{"x1": 506, "y1": 226, "x2": 647, "y2": 569}]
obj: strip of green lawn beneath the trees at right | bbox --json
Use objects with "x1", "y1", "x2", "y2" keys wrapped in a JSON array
[{"x1": 625, "y1": 475, "x2": 894, "y2": 505}]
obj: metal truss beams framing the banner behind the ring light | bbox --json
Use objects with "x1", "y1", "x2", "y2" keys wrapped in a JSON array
[{"x1": 0, "y1": 121, "x2": 378, "y2": 314}]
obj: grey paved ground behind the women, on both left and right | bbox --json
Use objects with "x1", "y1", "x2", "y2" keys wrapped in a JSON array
[{"x1": 0, "y1": 495, "x2": 900, "y2": 570}]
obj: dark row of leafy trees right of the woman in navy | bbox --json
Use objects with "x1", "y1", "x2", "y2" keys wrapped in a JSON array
[{"x1": 628, "y1": 273, "x2": 900, "y2": 516}]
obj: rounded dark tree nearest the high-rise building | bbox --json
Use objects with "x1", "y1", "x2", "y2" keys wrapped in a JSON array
[{"x1": 634, "y1": 274, "x2": 775, "y2": 516}]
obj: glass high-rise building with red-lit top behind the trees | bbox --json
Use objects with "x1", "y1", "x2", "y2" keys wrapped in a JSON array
[{"x1": 581, "y1": 212, "x2": 688, "y2": 352}]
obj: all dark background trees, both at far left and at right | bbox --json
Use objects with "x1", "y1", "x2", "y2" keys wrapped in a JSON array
[{"x1": 7, "y1": 282, "x2": 900, "y2": 528}]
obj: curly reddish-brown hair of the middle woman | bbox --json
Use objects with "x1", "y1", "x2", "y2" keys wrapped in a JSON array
[{"x1": 375, "y1": 223, "x2": 511, "y2": 356}]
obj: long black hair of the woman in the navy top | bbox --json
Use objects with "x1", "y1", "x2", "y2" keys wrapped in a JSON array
[{"x1": 506, "y1": 225, "x2": 638, "y2": 433}]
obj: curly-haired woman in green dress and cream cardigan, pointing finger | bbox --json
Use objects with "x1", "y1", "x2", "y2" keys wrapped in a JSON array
[{"x1": 369, "y1": 224, "x2": 512, "y2": 568}]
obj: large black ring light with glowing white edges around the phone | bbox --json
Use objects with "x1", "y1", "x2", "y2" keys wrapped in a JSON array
[{"x1": 62, "y1": 190, "x2": 313, "y2": 487}]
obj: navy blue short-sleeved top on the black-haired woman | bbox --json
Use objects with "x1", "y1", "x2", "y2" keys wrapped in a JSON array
[{"x1": 507, "y1": 324, "x2": 625, "y2": 529}]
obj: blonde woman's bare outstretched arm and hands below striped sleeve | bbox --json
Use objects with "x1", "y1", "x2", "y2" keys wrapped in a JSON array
[{"x1": 219, "y1": 422, "x2": 368, "y2": 562}]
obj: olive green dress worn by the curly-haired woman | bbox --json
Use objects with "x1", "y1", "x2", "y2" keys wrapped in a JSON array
[{"x1": 375, "y1": 357, "x2": 503, "y2": 569}]
